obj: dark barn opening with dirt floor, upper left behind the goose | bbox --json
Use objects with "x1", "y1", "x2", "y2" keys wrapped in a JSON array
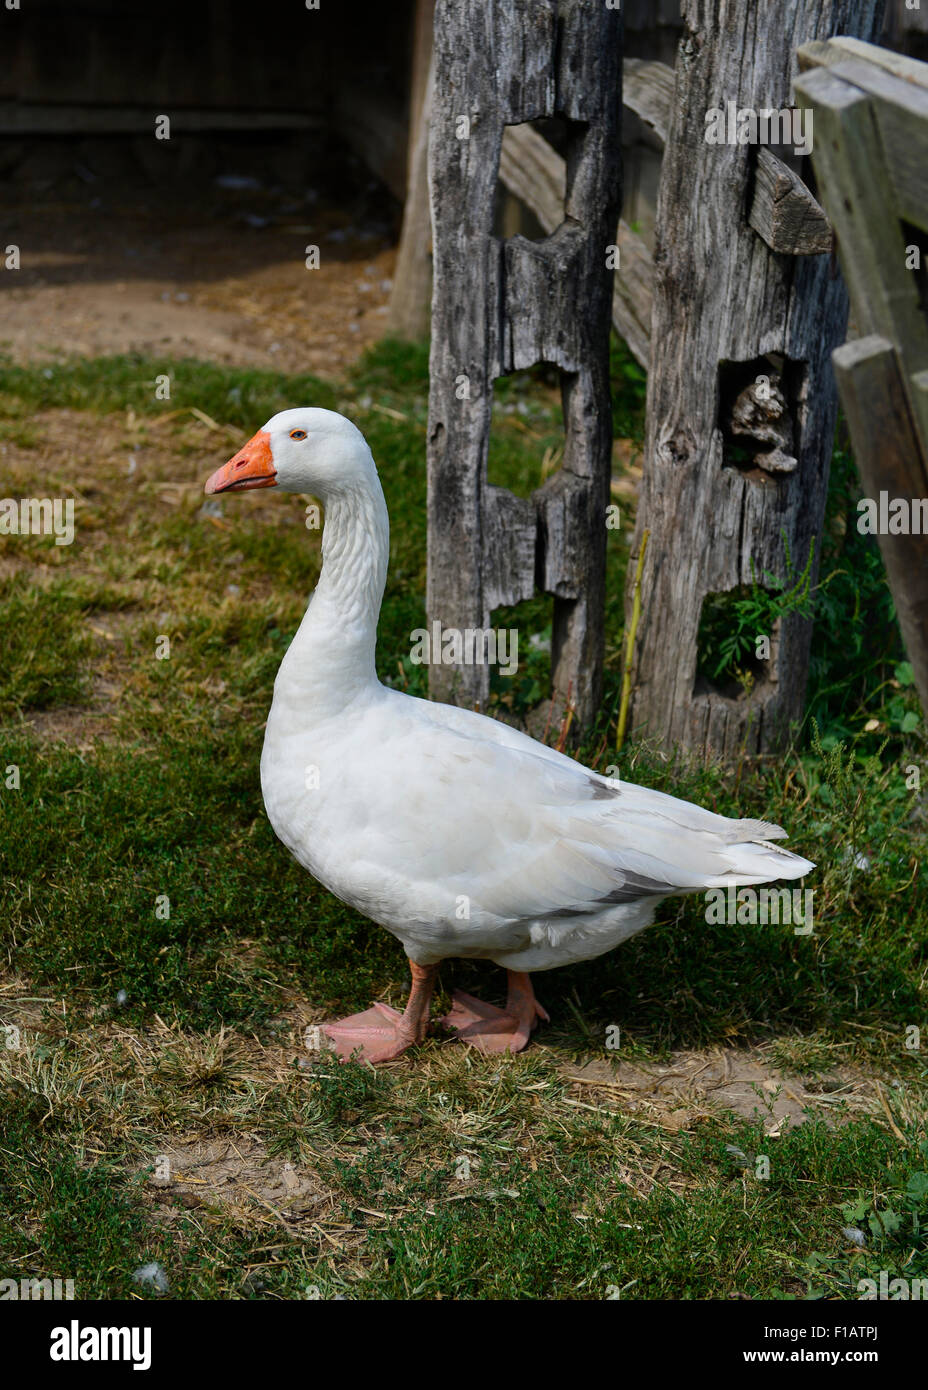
[{"x1": 0, "y1": 0, "x2": 413, "y2": 374}]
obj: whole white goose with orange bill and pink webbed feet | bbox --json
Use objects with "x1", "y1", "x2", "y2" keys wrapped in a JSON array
[{"x1": 206, "y1": 409, "x2": 814, "y2": 1062}]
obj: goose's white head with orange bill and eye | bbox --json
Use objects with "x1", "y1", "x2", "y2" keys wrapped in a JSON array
[{"x1": 204, "y1": 407, "x2": 375, "y2": 500}]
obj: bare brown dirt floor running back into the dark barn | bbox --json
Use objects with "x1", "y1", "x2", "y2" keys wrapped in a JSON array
[{"x1": 0, "y1": 132, "x2": 397, "y2": 377}]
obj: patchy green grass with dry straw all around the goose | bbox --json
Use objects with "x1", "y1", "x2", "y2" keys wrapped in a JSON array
[{"x1": 0, "y1": 343, "x2": 928, "y2": 1300}]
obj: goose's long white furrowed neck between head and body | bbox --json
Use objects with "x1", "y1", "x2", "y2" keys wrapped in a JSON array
[{"x1": 274, "y1": 463, "x2": 390, "y2": 719}]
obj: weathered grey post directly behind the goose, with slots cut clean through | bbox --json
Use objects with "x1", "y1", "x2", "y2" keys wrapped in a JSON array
[{"x1": 426, "y1": 0, "x2": 621, "y2": 726}]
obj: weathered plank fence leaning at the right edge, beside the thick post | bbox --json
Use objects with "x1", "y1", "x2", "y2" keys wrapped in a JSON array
[{"x1": 796, "y1": 38, "x2": 928, "y2": 712}]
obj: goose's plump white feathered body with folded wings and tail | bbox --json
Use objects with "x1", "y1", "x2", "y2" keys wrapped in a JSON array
[{"x1": 261, "y1": 669, "x2": 811, "y2": 970}]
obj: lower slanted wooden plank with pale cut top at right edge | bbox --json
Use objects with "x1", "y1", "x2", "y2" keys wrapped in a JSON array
[{"x1": 834, "y1": 335, "x2": 928, "y2": 710}]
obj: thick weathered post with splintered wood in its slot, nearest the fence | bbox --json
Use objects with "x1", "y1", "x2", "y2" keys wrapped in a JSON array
[{"x1": 627, "y1": 0, "x2": 881, "y2": 758}]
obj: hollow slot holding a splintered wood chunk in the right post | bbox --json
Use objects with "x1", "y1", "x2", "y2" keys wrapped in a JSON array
[{"x1": 718, "y1": 353, "x2": 804, "y2": 485}]
